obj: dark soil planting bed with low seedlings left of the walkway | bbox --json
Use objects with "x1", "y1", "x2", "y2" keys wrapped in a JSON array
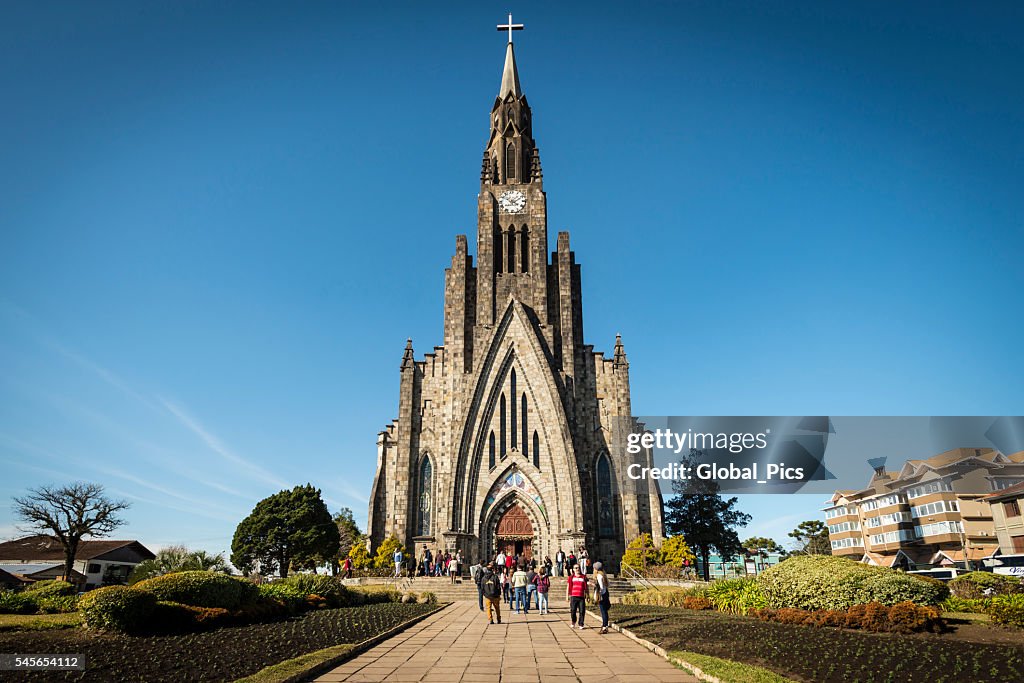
[{"x1": 0, "y1": 603, "x2": 436, "y2": 683}]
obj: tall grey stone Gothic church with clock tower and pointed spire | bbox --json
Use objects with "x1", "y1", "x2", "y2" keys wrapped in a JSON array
[{"x1": 369, "y1": 31, "x2": 664, "y2": 570}]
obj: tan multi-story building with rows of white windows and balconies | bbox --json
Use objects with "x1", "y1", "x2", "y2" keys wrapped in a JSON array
[{"x1": 824, "y1": 449, "x2": 1024, "y2": 569}]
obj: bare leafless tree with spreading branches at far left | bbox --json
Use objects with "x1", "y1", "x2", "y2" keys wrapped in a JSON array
[{"x1": 14, "y1": 482, "x2": 130, "y2": 581}]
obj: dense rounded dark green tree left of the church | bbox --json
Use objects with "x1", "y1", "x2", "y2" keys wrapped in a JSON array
[{"x1": 231, "y1": 483, "x2": 339, "y2": 578}]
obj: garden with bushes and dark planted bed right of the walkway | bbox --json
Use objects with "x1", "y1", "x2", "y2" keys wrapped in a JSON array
[{"x1": 611, "y1": 557, "x2": 1024, "y2": 683}]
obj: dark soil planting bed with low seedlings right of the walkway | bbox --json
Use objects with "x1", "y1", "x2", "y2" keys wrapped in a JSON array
[{"x1": 611, "y1": 605, "x2": 1024, "y2": 683}]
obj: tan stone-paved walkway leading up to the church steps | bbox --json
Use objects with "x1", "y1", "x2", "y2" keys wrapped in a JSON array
[{"x1": 316, "y1": 601, "x2": 697, "y2": 683}]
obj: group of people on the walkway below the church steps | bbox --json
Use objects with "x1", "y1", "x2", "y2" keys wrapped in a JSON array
[{"x1": 470, "y1": 551, "x2": 611, "y2": 633}]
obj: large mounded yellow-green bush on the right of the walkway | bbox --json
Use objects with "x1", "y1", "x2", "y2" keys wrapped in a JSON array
[{"x1": 757, "y1": 555, "x2": 946, "y2": 610}]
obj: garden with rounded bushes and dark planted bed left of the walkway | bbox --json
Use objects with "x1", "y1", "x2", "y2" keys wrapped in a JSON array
[{"x1": 0, "y1": 571, "x2": 437, "y2": 682}]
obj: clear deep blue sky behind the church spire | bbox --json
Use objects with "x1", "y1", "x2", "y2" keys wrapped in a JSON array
[{"x1": 0, "y1": 2, "x2": 1024, "y2": 551}]
